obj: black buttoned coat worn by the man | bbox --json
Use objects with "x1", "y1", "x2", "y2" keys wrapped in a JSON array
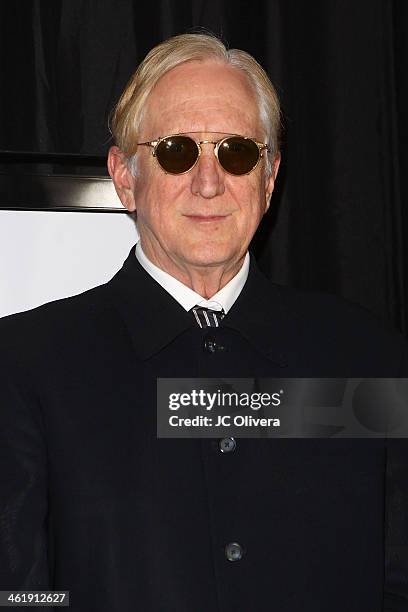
[{"x1": 0, "y1": 249, "x2": 408, "y2": 612}]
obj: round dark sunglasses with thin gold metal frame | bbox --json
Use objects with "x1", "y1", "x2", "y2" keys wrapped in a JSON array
[{"x1": 138, "y1": 132, "x2": 269, "y2": 176}]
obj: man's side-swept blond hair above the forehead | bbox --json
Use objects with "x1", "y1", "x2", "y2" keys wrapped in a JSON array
[{"x1": 110, "y1": 34, "x2": 281, "y2": 170}]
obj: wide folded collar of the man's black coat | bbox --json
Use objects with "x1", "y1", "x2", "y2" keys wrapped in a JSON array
[{"x1": 106, "y1": 246, "x2": 292, "y2": 367}]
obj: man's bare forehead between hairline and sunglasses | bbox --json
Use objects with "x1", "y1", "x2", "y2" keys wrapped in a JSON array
[{"x1": 141, "y1": 61, "x2": 261, "y2": 139}]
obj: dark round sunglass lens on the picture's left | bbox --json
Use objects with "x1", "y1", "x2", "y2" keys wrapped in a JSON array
[{"x1": 156, "y1": 136, "x2": 198, "y2": 174}]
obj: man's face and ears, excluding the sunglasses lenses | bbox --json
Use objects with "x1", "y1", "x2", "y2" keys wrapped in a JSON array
[{"x1": 110, "y1": 61, "x2": 279, "y2": 270}]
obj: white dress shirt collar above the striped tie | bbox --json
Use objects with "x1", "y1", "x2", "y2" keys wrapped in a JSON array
[{"x1": 136, "y1": 240, "x2": 249, "y2": 314}]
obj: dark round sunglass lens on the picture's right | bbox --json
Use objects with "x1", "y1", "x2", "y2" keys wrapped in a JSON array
[{"x1": 218, "y1": 136, "x2": 259, "y2": 174}]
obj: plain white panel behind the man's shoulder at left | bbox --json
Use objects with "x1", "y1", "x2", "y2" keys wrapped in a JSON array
[{"x1": 0, "y1": 210, "x2": 137, "y2": 316}]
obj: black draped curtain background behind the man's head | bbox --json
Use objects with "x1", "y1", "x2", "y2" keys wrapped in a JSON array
[{"x1": 0, "y1": 0, "x2": 408, "y2": 332}]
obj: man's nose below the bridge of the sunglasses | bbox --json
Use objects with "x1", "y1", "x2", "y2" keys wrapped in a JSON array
[{"x1": 191, "y1": 143, "x2": 225, "y2": 199}]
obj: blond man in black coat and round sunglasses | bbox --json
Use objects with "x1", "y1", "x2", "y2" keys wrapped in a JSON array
[{"x1": 0, "y1": 34, "x2": 408, "y2": 612}]
